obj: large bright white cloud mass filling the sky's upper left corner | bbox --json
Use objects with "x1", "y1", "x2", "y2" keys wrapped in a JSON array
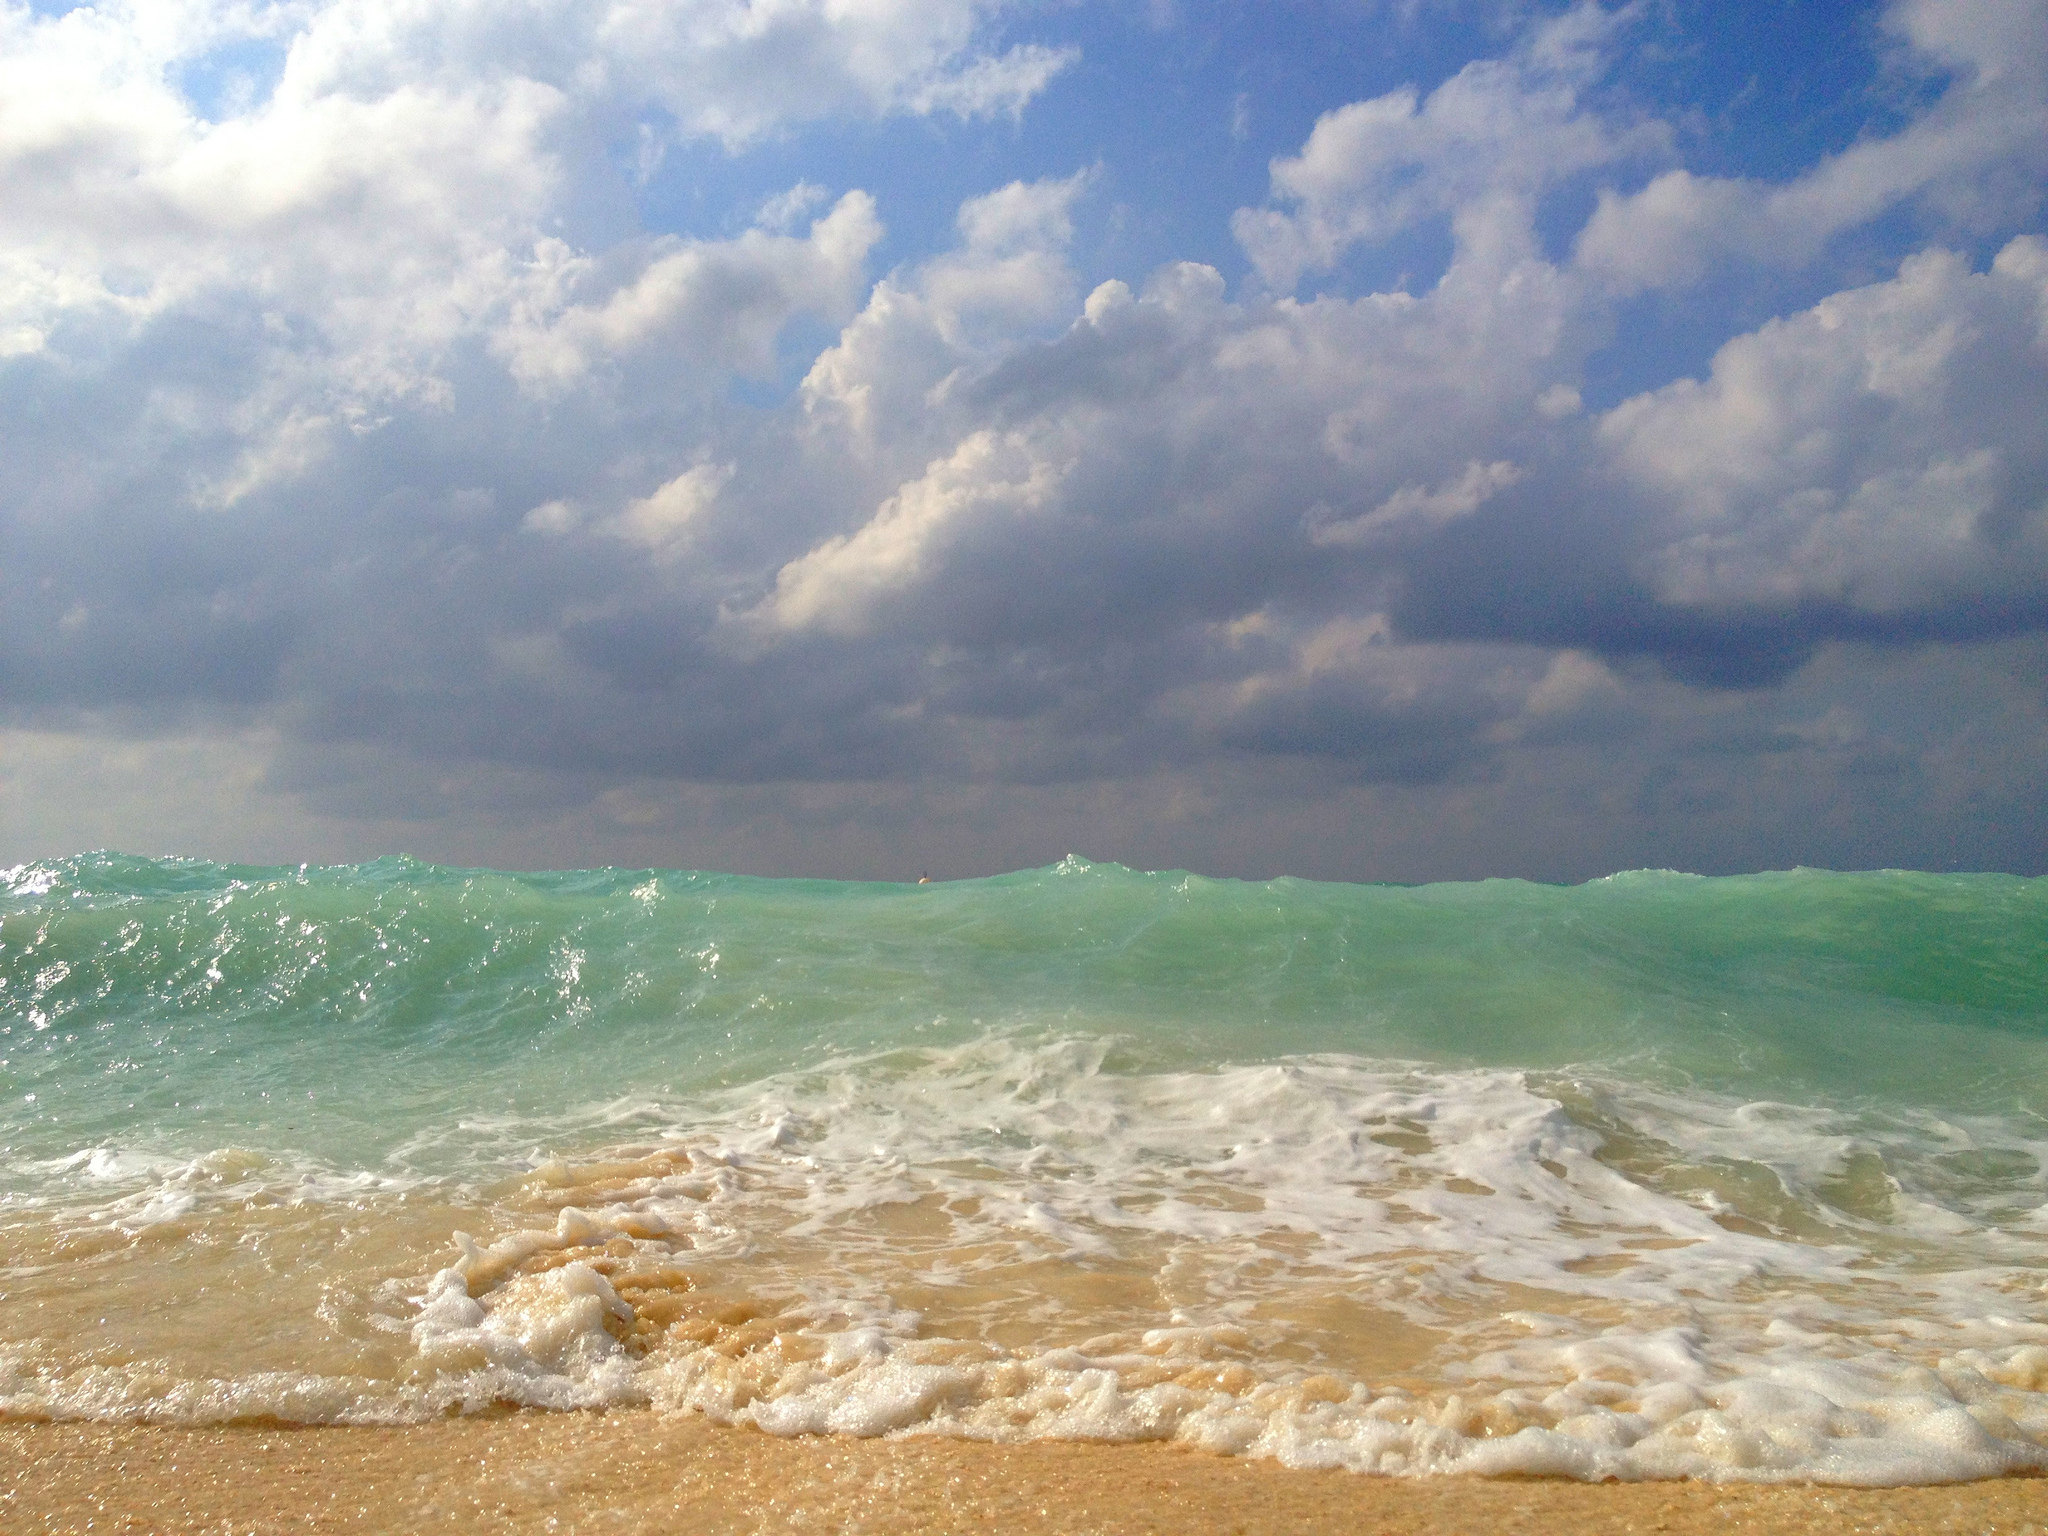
[{"x1": 0, "y1": 0, "x2": 1069, "y2": 487}]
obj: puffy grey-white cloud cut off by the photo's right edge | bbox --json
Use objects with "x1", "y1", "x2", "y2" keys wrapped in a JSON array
[{"x1": 1599, "y1": 238, "x2": 2048, "y2": 614}]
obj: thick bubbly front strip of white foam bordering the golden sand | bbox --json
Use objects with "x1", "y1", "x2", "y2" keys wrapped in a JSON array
[{"x1": 626, "y1": 1310, "x2": 2048, "y2": 1485}]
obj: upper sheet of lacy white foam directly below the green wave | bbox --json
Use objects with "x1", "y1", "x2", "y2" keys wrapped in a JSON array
[{"x1": 528, "y1": 1040, "x2": 2015, "y2": 1321}]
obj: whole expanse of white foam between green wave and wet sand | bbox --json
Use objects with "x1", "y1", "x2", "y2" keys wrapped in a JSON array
[{"x1": 0, "y1": 1038, "x2": 2048, "y2": 1485}]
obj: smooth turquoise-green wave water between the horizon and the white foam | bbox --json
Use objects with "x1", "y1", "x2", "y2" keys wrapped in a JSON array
[{"x1": 0, "y1": 854, "x2": 2048, "y2": 1159}]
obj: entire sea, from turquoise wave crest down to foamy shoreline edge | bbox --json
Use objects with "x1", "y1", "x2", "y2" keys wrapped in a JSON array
[{"x1": 0, "y1": 854, "x2": 2048, "y2": 1483}]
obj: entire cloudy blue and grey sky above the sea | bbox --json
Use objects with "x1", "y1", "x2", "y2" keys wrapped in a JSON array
[{"x1": 0, "y1": 0, "x2": 2048, "y2": 881}]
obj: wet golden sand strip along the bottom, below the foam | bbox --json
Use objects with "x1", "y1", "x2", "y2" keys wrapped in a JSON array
[{"x1": 0, "y1": 1411, "x2": 2048, "y2": 1536}]
